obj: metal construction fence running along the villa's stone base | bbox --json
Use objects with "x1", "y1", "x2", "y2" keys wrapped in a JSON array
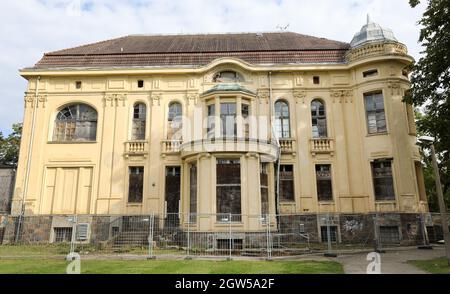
[{"x1": 0, "y1": 213, "x2": 449, "y2": 259}]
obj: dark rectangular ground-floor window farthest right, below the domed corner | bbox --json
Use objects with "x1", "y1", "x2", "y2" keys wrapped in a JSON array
[{"x1": 371, "y1": 159, "x2": 395, "y2": 201}]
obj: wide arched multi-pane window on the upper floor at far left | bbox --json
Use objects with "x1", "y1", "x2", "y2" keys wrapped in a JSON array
[{"x1": 53, "y1": 104, "x2": 97, "y2": 142}]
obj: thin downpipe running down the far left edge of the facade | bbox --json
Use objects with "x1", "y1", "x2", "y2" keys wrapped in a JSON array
[{"x1": 14, "y1": 76, "x2": 41, "y2": 243}]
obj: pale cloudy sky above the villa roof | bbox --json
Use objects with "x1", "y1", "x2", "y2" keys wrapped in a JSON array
[{"x1": 0, "y1": 0, "x2": 425, "y2": 134}]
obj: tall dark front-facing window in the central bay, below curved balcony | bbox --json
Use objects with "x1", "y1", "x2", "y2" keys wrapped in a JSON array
[{"x1": 216, "y1": 159, "x2": 241, "y2": 222}]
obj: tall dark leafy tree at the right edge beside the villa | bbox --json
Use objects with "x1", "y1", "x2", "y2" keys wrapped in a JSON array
[{"x1": 404, "y1": 0, "x2": 450, "y2": 209}]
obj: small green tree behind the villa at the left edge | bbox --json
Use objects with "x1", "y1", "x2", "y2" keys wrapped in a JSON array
[{"x1": 0, "y1": 123, "x2": 22, "y2": 166}]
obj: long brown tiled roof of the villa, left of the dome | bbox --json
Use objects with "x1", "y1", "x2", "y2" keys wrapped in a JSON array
[{"x1": 35, "y1": 32, "x2": 349, "y2": 68}]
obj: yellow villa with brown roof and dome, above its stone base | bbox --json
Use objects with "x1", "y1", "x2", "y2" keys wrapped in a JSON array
[{"x1": 12, "y1": 21, "x2": 428, "y2": 235}]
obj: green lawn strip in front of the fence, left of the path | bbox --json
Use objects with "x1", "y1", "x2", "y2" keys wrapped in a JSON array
[{"x1": 0, "y1": 259, "x2": 343, "y2": 274}]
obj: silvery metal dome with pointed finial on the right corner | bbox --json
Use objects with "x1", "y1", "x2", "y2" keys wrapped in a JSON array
[{"x1": 350, "y1": 16, "x2": 398, "y2": 47}]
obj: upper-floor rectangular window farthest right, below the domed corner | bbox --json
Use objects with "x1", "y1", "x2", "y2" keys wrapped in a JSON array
[{"x1": 364, "y1": 92, "x2": 387, "y2": 134}]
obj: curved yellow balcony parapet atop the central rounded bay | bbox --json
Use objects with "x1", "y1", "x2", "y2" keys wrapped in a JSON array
[{"x1": 180, "y1": 137, "x2": 278, "y2": 162}]
